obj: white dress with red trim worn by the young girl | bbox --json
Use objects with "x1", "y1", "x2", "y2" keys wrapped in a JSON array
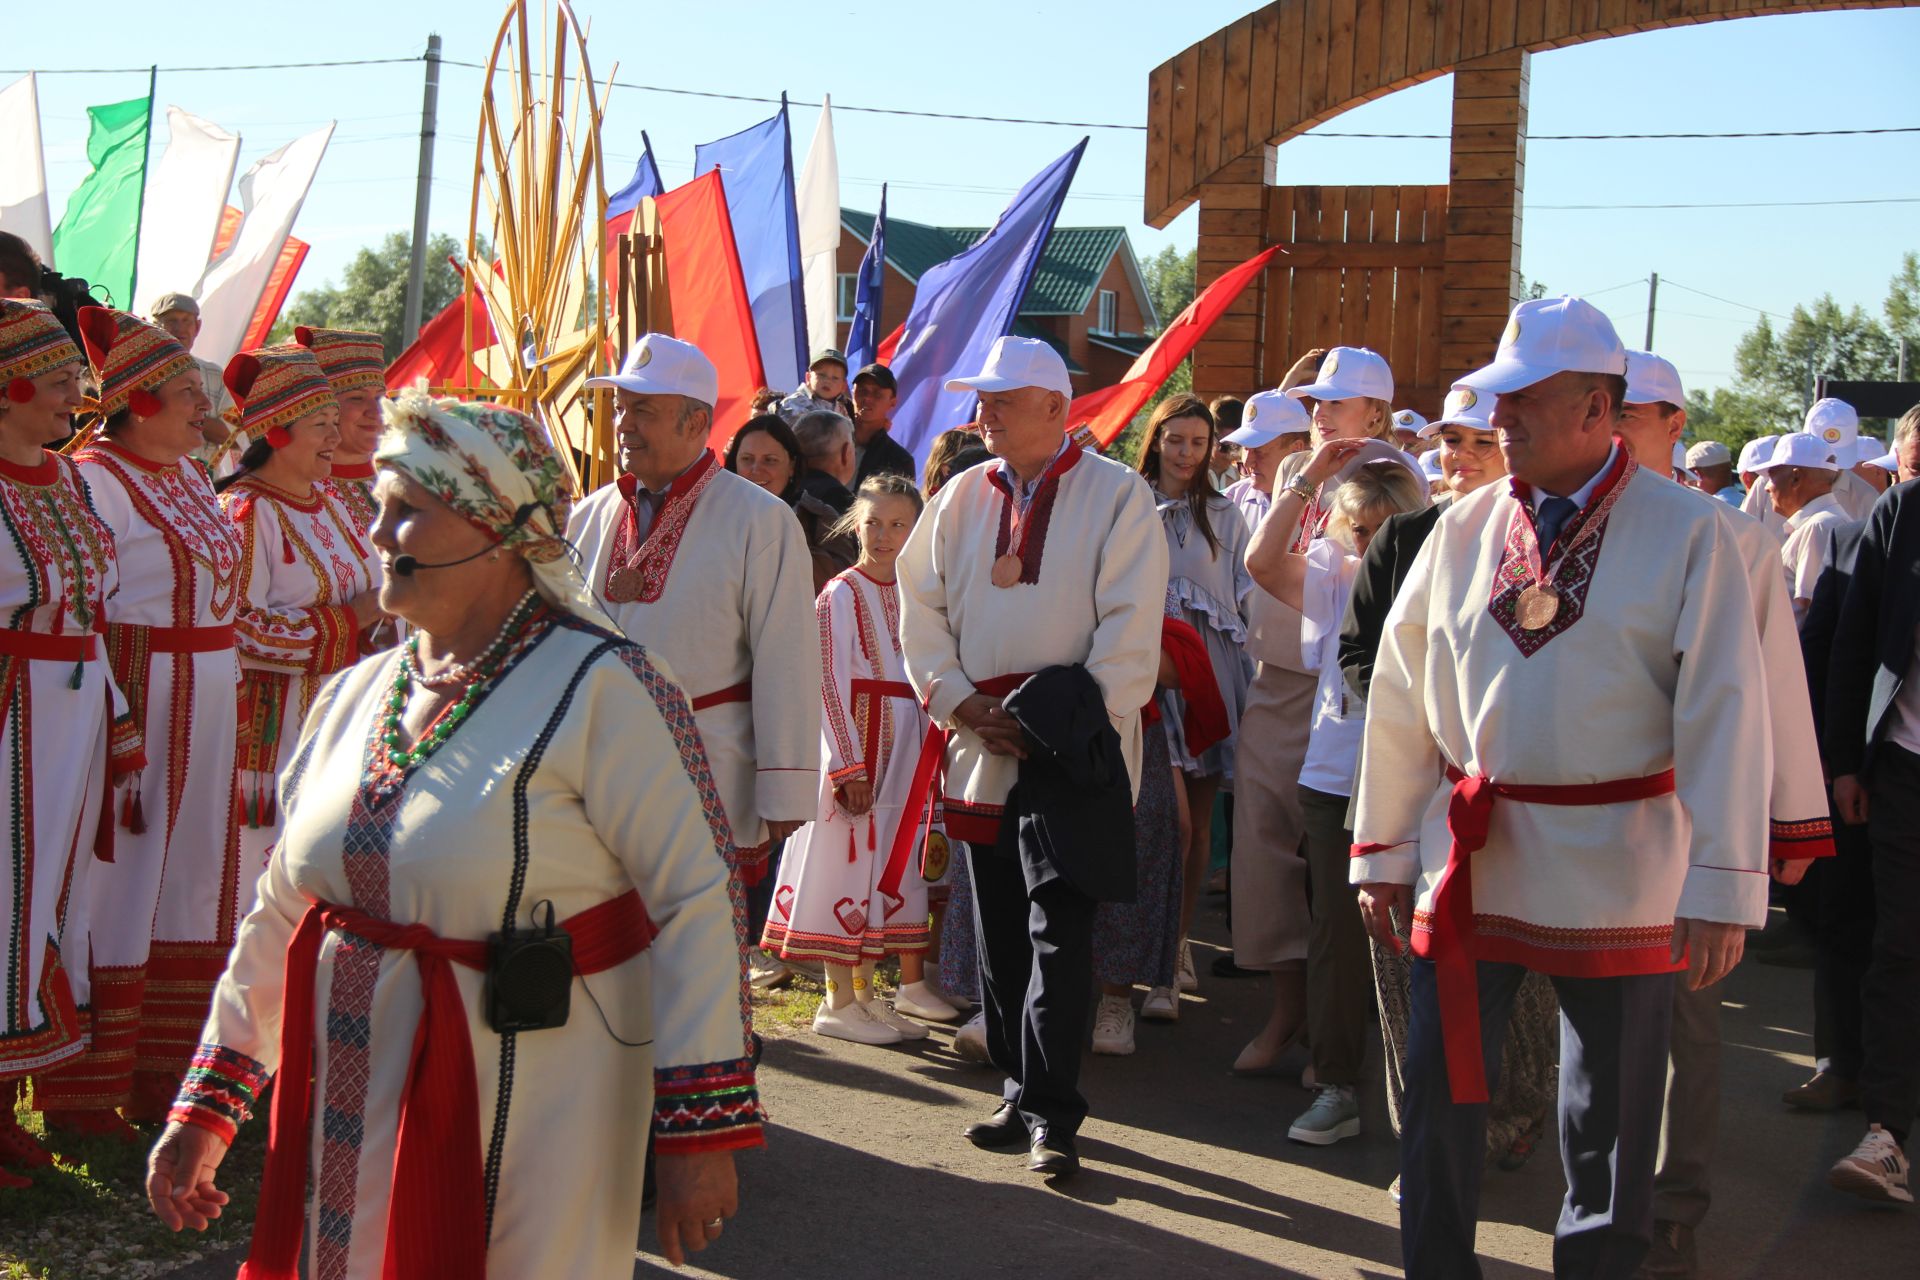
[{"x1": 762, "y1": 568, "x2": 931, "y2": 965}]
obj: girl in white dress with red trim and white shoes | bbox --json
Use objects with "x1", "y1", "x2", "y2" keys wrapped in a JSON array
[{"x1": 760, "y1": 476, "x2": 954, "y2": 1044}]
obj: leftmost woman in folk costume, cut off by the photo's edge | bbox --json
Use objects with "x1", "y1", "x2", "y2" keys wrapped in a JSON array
[{"x1": 0, "y1": 299, "x2": 142, "y2": 1188}]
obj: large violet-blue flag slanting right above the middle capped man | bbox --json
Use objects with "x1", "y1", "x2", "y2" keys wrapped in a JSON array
[{"x1": 893, "y1": 138, "x2": 1087, "y2": 466}]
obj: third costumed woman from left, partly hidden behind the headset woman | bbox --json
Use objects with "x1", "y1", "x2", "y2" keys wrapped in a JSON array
[{"x1": 215, "y1": 345, "x2": 386, "y2": 867}]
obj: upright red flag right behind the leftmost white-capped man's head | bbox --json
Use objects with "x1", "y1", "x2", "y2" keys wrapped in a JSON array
[{"x1": 655, "y1": 169, "x2": 766, "y2": 453}]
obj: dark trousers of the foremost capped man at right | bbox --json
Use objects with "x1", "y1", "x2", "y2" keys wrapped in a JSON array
[{"x1": 1400, "y1": 960, "x2": 1674, "y2": 1280}]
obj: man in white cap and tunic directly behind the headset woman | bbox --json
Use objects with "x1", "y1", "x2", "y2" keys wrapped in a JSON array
[{"x1": 566, "y1": 334, "x2": 820, "y2": 940}]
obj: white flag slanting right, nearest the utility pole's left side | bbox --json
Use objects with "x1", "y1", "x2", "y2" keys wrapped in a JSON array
[{"x1": 194, "y1": 125, "x2": 334, "y2": 365}]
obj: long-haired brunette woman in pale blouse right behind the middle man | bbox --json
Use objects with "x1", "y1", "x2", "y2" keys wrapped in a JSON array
[{"x1": 1139, "y1": 395, "x2": 1254, "y2": 1021}]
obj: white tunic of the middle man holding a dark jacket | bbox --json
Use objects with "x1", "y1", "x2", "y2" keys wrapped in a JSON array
[{"x1": 899, "y1": 445, "x2": 1167, "y2": 844}]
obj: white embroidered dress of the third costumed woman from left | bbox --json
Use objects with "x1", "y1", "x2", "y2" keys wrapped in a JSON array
[{"x1": 221, "y1": 476, "x2": 380, "y2": 867}]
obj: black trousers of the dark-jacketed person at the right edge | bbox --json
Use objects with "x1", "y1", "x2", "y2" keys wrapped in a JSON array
[{"x1": 1860, "y1": 743, "x2": 1920, "y2": 1144}]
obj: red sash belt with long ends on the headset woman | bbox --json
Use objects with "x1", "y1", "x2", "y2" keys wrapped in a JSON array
[{"x1": 240, "y1": 889, "x2": 659, "y2": 1280}]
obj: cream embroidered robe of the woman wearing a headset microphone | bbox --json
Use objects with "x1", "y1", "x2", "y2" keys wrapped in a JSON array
[{"x1": 175, "y1": 616, "x2": 760, "y2": 1280}]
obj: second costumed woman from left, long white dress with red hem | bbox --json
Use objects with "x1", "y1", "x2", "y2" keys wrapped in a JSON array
[{"x1": 35, "y1": 307, "x2": 253, "y2": 1142}]
